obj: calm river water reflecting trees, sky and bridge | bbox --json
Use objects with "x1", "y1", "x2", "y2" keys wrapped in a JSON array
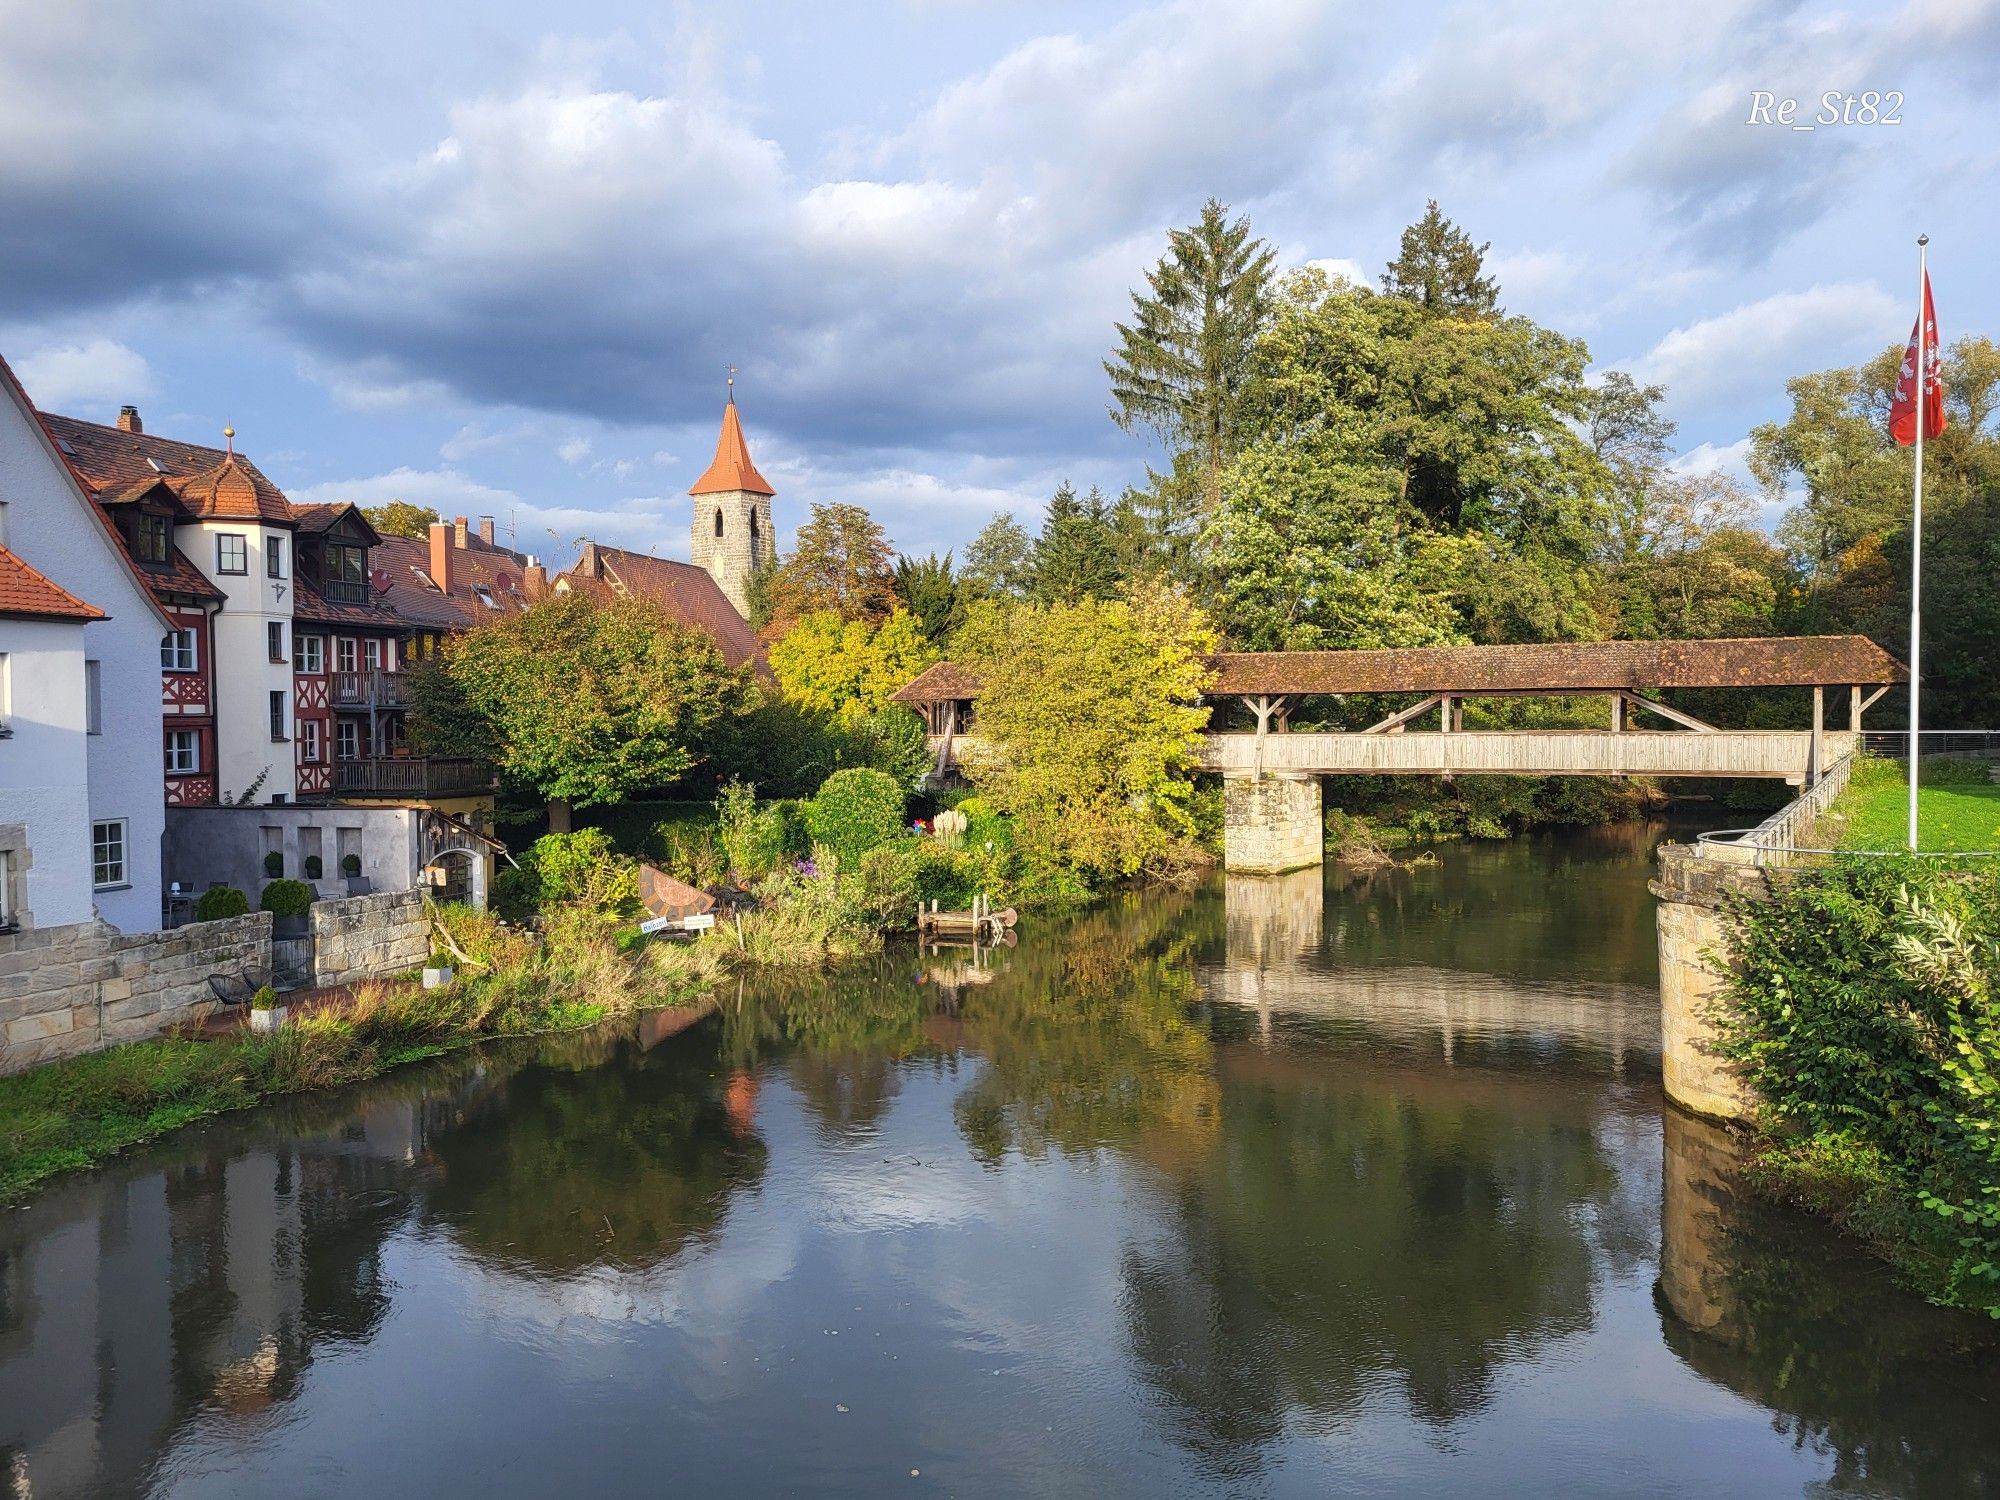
[{"x1": 0, "y1": 830, "x2": 2000, "y2": 1500}]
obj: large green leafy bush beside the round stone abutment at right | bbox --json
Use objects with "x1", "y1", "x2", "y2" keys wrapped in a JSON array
[{"x1": 1724, "y1": 856, "x2": 2000, "y2": 1316}]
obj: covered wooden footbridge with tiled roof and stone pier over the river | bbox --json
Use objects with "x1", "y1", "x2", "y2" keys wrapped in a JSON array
[{"x1": 896, "y1": 636, "x2": 1906, "y2": 870}]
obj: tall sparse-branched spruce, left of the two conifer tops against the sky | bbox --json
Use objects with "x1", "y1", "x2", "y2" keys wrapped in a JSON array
[{"x1": 1104, "y1": 198, "x2": 1274, "y2": 506}]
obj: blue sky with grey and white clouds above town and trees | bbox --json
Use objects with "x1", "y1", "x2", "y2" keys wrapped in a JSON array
[{"x1": 0, "y1": 0, "x2": 2000, "y2": 562}]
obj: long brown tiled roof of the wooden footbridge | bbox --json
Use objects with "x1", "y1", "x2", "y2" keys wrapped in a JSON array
[{"x1": 896, "y1": 636, "x2": 1908, "y2": 704}]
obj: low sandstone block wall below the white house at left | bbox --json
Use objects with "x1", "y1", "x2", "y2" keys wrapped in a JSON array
[{"x1": 0, "y1": 912, "x2": 270, "y2": 1074}]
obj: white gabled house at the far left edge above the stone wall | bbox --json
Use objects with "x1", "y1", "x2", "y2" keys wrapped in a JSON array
[{"x1": 0, "y1": 360, "x2": 170, "y2": 932}]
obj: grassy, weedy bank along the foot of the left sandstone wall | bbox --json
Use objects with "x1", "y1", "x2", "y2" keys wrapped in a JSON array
[{"x1": 0, "y1": 912, "x2": 730, "y2": 1202}]
